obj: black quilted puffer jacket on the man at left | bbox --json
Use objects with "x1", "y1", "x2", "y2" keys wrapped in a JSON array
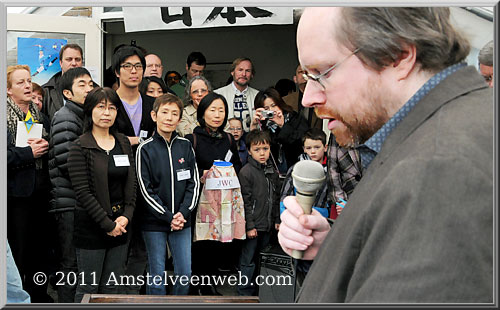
[{"x1": 49, "y1": 100, "x2": 83, "y2": 212}]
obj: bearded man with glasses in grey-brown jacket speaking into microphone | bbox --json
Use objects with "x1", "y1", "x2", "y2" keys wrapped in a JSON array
[{"x1": 278, "y1": 7, "x2": 495, "y2": 303}]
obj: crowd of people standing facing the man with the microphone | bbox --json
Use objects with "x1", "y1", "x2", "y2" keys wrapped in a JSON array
[{"x1": 7, "y1": 35, "x2": 348, "y2": 303}]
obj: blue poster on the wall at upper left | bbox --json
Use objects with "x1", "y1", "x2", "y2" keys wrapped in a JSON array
[{"x1": 17, "y1": 38, "x2": 68, "y2": 85}]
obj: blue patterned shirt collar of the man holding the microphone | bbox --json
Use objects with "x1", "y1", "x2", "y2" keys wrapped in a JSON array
[{"x1": 358, "y1": 63, "x2": 467, "y2": 168}]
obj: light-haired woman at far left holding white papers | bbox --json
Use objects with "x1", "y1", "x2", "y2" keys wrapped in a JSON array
[{"x1": 6, "y1": 65, "x2": 52, "y2": 303}]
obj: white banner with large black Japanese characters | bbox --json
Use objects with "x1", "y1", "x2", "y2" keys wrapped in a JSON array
[{"x1": 123, "y1": 7, "x2": 293, "y2": 32}]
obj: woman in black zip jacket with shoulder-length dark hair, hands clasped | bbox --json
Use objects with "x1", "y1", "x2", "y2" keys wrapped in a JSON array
[{"x1": 68, "y1": 87, "x2": 137, "y2": 302}]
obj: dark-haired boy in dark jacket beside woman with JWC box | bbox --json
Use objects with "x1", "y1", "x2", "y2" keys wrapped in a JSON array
[{"x1": 238, "y1": 130, "x2": 279, "y2": 296}]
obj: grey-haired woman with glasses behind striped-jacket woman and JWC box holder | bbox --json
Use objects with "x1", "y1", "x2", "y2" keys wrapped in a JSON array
[{"x1": 177, "y1": 75, "x2": 212, "y2": 137}]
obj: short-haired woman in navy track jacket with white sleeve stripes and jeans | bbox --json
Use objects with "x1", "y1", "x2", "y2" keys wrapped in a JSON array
[{"x1": 136, "y1": 94, "x2": 200, "y2": 295}]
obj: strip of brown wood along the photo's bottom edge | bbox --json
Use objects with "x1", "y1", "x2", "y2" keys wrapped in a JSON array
[{"x1": 82, "y1": 294, "x2": 259, "y2": 304}]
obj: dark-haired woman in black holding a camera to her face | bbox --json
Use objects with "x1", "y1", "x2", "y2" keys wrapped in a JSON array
[{"x1": 250, "y1": 87, "x2": 309, "y2": 175}]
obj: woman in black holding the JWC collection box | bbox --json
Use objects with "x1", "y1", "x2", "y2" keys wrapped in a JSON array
[{"x1": 186, "y1": 93, "x2": 241, "y2": 295}]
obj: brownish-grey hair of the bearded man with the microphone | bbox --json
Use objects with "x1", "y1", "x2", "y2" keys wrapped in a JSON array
[{"x1": 336, "y1": 7, "x2": 470, "y2": 72}]
